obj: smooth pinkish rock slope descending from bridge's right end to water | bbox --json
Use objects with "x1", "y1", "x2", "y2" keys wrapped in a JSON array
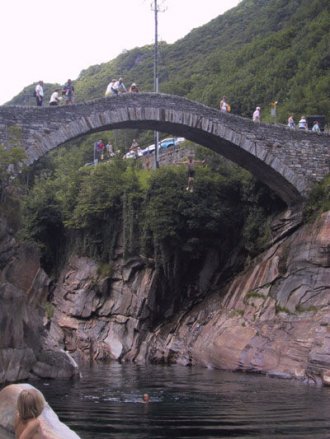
[{"x1": 145, "y1": 212, "x2": 330, "y2": 384}]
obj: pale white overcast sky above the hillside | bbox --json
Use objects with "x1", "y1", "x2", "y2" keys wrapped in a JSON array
[{"x1": 0, "y1": 0, "x2": 240, "y2": 105}]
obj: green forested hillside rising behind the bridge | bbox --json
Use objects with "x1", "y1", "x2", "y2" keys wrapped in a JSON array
[{"x1": 6, "y1": 0, "x2": 330, "y2": 122}]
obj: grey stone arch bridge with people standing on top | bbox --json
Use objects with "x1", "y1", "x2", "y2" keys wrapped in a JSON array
[{"x1": 0, "y1": 93, "x2": 330, "y2": 205}]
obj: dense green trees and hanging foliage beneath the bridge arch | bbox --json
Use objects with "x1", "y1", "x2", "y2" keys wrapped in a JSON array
[{"x1": 20, "y1": 138, "x2": 283, "y2": 278}]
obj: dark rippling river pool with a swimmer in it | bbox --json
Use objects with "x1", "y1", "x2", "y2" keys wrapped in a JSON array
[{"x1": 33, "y1": 364, "x2": 330, "y2": 439}]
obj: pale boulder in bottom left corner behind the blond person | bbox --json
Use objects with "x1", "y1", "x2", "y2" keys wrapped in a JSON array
[{"x1": 0, "y1": 383, "x2": 79, "y2": 439}]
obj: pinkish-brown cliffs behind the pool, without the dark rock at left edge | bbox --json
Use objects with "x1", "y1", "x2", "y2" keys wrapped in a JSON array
[{"x1": 49, "y1": 212, "x2": 330, "y2": 384}]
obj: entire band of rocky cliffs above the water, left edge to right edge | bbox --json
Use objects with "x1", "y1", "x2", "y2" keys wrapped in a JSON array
[{"x1": 0, "y1": 212, "x2": 330, "y2": 384}]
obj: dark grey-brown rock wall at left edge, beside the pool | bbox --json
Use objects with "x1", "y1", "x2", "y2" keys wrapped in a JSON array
[{"x1": 0, "y1": 219, "x2": 78, "y2": 382}]
